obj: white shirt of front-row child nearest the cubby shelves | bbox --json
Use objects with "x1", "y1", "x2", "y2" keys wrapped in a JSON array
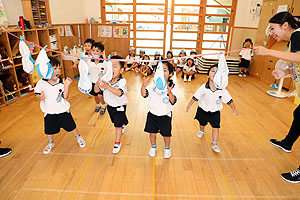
[{"x1": 34, "y1": 78, "x2": 70, "y2": 116}]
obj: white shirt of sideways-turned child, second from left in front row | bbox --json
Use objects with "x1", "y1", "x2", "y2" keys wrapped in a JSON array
[{"x1": 103, "y1": 77, "x2": 128, "y2": 107}]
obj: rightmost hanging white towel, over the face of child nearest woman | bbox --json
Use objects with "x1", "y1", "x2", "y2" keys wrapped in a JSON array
[{"x1": 213, "y1": 54, "x2": 229, "y2": 89}]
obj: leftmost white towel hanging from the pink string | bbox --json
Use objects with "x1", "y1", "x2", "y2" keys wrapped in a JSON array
[{"x1": 19, "y1": 36, "x2": 35, "y2": 74}]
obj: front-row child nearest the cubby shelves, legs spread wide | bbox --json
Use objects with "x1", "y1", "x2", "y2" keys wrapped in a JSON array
[{"x1": 34, "y1": 57, "x2": 86, "y2": 154}]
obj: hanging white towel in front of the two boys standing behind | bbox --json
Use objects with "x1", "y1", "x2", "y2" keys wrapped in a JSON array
[{"x1": 78, "y1": 56, "x2": 92, "y2": 94}]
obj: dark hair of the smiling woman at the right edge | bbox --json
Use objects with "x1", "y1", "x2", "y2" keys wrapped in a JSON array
[{"x1": 269, "y1": 11, "x2": 300, "y2": 29}]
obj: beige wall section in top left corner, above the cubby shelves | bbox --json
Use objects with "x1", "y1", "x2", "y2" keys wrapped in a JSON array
[{"x1": 2, "y1": 0, "x2": 24, "y2": 25}]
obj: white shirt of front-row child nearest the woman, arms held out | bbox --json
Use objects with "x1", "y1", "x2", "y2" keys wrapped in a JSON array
[{"x1": 193, "y1": 82, "x2": 232, "y2": 112}]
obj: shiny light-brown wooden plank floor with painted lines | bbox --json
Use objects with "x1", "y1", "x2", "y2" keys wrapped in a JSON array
[{"x1": 0, "y1": 72, "x2": 300, "y2": 200}]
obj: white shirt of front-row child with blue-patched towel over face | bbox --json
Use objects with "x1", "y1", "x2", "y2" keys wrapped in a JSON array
[{"x1": 146, "y1": 82, "x2": 178, "y2": 117}]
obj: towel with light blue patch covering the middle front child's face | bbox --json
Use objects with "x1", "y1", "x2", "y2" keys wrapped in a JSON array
[{"x1": 153, "y1": 61, "x2": 168, "y2": 94}]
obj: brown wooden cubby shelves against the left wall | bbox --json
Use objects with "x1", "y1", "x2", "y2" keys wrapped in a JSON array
[{"x1": 0, "y1": 28, "x2": 64, "y2": 105}]
